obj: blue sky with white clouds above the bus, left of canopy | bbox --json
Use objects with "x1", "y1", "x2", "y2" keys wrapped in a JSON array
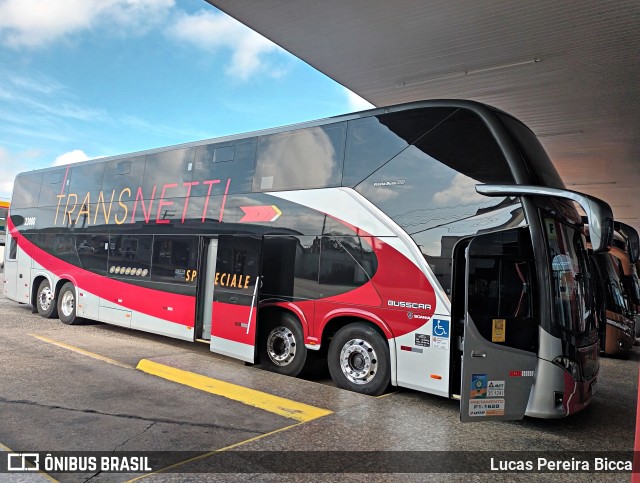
[{"x1": 0, "y1": 0, "x2": 372, "y2": 200}]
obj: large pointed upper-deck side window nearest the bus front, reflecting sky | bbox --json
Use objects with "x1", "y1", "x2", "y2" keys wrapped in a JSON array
[{"x1": 356, "y1": 109, "x2": 524, "y2": 291}]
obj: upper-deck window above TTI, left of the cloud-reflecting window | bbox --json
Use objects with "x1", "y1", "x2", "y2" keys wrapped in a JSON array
[{"x1": 191, "y1": 139, "x2": 256, "y2": 197}]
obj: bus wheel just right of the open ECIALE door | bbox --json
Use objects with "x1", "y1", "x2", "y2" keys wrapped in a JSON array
[{"x1": 259, "y1": 313, "x2": 307, "y2": 376}]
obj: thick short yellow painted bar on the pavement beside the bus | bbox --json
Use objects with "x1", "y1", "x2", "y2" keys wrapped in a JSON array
[{"x1": 136, "y1": 359, "x2": 333, "y2": 423}]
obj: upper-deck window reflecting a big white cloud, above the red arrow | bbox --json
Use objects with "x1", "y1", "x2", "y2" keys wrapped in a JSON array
[{"x1": 253, "y1": 123, "x2": 346, "y2": 191}]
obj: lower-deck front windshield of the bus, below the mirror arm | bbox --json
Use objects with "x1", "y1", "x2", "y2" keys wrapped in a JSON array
[{"x1": 544, "y1": 214, "x2": 597, "y2": 335}]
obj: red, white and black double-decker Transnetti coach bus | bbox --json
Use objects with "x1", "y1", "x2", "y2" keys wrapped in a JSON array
[{"x1": 4, "y1": 100, "x2": 613, "y2": 421}]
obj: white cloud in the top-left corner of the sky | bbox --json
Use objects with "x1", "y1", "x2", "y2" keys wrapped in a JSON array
[{"x1": 0, "y1": 0, "x2": 175, "y2": 48}]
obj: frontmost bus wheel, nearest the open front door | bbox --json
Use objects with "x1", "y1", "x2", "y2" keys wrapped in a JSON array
[{"x1": 328, "y1": 323, "x2": 391, "y2": 396}]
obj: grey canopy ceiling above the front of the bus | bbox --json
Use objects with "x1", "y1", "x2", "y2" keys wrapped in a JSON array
[{"x1": 207, "y1": 0, "x2": 640, "y2": 234}]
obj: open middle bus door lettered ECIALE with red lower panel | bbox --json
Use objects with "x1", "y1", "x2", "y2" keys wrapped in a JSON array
[{"x1": 203, "y1": 235, "x2": 262, "y2": 363}]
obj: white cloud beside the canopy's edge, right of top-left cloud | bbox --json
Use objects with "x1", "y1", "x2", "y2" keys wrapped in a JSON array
[{"x1": 167, "y1": 10, "x2": 287, "y2": 80}]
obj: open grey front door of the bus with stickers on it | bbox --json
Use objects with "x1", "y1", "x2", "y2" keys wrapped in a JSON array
[{"x1": 459, "y1": 228, "x2": 539, "y2": 421}]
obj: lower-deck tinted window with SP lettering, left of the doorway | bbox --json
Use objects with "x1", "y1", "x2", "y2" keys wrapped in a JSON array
[{"x1": 151, "y1": 236, "x2": 198, "y2": 285}]
